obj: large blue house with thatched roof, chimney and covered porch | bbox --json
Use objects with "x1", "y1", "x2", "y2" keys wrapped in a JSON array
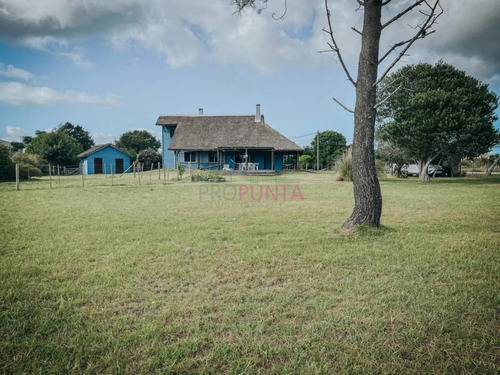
[{"x1": 156, "y1": 104, "x2": 302, "y2": 170}]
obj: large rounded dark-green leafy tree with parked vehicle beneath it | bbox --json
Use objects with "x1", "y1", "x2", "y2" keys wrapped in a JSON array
[{"x1": 379, "y1": 62, "x2": 498, "y2": 181}]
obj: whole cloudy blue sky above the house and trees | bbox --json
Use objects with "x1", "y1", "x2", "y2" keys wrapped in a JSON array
[{"x1": 0, "y1": 0, "x2": 500, "y2": 151}]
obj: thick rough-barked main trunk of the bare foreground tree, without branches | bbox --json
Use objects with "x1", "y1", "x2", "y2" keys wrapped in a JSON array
[{"x1": 343, "y1": 0, "x2": 382, "y2": 229}]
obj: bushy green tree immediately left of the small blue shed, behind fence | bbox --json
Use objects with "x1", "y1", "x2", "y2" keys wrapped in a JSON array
[{"x1": 26, "y1": 131, "x2": 84, "y2": 165}]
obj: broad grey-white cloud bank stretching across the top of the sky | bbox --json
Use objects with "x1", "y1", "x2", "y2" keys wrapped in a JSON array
[{"x1": 0, "y1": 0, "x2": 500, "y2": 83}]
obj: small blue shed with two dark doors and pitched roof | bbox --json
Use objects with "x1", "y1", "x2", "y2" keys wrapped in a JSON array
[{"x1": 77, "y1": 143, "x2": 132, "y2": 174}]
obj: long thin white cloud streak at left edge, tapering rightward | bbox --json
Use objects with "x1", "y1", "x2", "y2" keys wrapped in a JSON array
[{"x1": 0, "y1": 82, "x2": 120, "y2": 106}]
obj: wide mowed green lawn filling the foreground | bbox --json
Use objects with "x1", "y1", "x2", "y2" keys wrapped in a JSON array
[{"x1": 0, "y1": 173, "x2": 500, "y2": 374}]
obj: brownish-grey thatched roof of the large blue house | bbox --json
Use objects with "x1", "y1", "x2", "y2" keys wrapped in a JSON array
[{"x1": 156, "y1": 115, "x2": 302, "y2": 151}]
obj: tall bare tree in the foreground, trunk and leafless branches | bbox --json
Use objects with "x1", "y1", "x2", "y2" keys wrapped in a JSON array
[{"x1": 235, "y1": 0, "x2": 443, "y2": 229}]
